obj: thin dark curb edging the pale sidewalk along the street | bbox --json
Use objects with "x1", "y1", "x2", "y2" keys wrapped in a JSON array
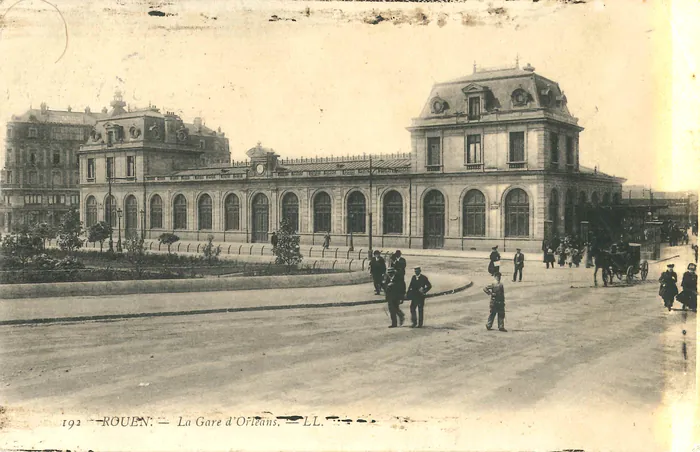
[{"x1": 0, "y1": 281, "x2": 474, "y2": 326}]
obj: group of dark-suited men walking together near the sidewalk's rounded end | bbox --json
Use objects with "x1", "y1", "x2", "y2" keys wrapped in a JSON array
[{"x1": 369, "y1": 250, "x2": 433, "y2": 328}]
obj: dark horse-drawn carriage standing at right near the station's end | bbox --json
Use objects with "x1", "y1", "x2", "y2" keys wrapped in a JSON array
[{"x1": 594, "y1": 243, "x2": 649, "y2": 285}]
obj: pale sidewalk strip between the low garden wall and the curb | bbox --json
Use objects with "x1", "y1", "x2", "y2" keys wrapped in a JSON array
[{"x1": 0, "y1": 274, "x2": 471, "y2": 325}]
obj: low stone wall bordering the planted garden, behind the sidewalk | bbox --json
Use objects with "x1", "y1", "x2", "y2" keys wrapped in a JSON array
[{"x1": 0, "y1": 271, "x2": 370, "y2": 299}]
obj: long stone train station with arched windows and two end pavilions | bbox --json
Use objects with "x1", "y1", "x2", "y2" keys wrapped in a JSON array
[{"x1": 78, "y1": 65, "x2": 624, "y2": 250}]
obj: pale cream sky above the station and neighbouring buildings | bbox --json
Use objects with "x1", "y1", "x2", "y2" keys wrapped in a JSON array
[{"x1": 0, "y1": 0, "x2": 700, "y2": 190}]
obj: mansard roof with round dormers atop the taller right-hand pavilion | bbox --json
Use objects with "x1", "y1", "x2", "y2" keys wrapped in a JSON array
[{"x1": 418, "y1": 65, "x2": 577, "y2": 124}]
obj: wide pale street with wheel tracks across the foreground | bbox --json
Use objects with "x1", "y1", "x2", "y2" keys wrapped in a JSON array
[{"x1": 0, "y1": 247, "x2": 696, "y2": 451}]
